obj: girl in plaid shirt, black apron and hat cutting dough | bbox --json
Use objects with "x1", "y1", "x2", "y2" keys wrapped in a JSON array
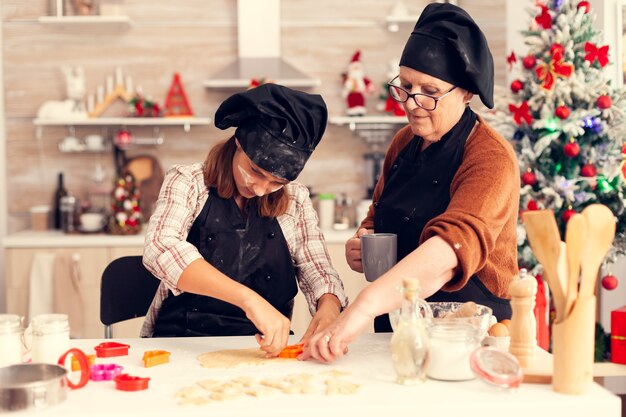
[{"x1": 141, "y1": 84, "x2": 347, "y2": 356}]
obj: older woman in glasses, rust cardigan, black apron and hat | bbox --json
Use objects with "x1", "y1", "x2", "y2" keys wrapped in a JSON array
[{"x1": 301, "y1": 3, "x2": 520, "y2": 361}]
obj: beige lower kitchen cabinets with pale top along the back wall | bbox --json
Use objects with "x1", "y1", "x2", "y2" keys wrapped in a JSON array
[{"x1": 3, "y1": 230, "x2": 360, "y2": 338}]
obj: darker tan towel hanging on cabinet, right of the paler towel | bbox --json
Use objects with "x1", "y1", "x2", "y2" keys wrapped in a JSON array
[{"x1": 54, "y1": 253, "x2": 85, "y2": 338}]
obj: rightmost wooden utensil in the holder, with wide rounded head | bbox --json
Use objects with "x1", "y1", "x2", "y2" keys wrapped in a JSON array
[{"x1": 579, "y1": 204, "x2": 615, "y2": 297}]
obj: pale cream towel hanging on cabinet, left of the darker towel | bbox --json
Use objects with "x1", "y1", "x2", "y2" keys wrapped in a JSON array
[{"x1": 28, "y1": 252, "x2": 55, "y2": 321}]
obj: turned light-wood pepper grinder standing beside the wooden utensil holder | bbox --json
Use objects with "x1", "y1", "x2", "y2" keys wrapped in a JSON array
[{"x1": 509, "y1": 269, "x2": 537, "y2": 369}]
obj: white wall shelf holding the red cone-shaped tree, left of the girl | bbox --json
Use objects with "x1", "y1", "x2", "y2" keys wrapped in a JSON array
[{"x1": 33, "y1": 117, "x2": 211, "y2": 139}]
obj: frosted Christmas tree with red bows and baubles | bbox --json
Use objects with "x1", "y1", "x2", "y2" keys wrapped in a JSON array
[{"x1": 486, "y1": 0, "x2": 626, "y2": 290}]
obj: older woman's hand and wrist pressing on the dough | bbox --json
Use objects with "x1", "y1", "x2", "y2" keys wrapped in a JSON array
[{"x1": 298, "y1": 303, "x2": 374, "y2": 363}]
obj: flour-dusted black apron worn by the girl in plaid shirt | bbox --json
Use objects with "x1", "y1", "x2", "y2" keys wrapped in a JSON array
[{"x1": 152, "y1": 188, "x2": 298, "y2": 337}]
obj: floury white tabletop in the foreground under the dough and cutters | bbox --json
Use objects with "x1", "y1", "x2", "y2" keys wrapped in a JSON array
[{"x1": 11, "y1": 334, "x2": 621, "y2": 417}]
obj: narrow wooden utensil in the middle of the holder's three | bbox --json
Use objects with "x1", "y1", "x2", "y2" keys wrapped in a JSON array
[{"x1": 565, "y1": 213, "x2": 587, "y2": 318}]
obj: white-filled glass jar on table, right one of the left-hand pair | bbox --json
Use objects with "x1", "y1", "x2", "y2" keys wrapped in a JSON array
[{"x1": 30, "y1": 314, "x2": 70, "y2": 364}]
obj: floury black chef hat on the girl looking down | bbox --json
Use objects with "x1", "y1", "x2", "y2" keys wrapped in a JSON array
[{"x1": 215, "y1": 84, "x2": 328, "y2": 181}]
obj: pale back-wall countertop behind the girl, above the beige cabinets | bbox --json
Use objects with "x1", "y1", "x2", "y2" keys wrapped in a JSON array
[{"x1": 2, "y1": 229, "x2": 356, "y2": 249}]
